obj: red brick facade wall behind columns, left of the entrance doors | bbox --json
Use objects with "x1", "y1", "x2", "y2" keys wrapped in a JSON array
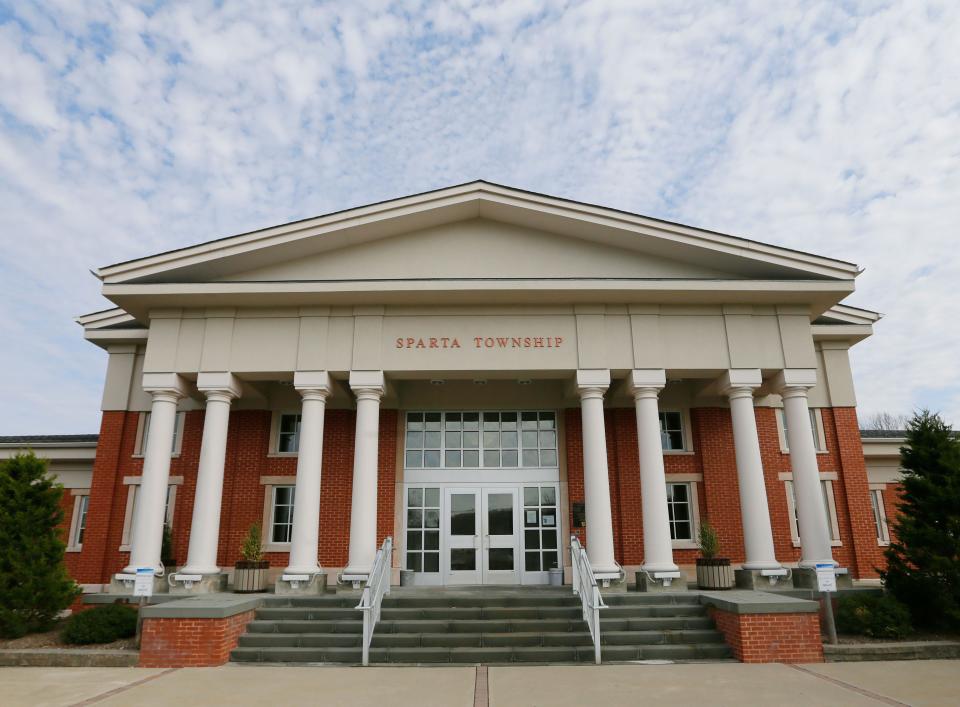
[{"x1": 72, "y1": 410, "x2": 397, "y2": 583}]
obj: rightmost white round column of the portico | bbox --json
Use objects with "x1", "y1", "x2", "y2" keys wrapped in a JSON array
[{"x1": 777, "y1": 369, "x2": 836, "y2": 568}]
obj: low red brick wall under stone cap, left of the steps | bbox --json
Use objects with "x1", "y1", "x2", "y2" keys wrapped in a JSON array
[{"x1": 140, "y1": 611, "x2": 254, "y2": 668}]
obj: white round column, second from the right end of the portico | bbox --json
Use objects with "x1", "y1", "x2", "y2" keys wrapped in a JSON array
[{"x1": 721, "y1": 368, "x2": 781, "y2": 570}]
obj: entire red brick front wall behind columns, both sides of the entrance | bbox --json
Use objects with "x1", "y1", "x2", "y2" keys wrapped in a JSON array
[{"x1": 73, "y1": 408, "x2": 895, "y2": 583}]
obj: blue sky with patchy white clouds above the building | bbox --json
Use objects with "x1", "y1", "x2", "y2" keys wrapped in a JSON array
[{"x1": 0, "y1": 0, "x2": 960, "y2": 435}]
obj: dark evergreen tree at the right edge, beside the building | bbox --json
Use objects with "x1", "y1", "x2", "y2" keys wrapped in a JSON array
[{"x1": 880, "y1": 410, "x2": 960, "y2": 630}]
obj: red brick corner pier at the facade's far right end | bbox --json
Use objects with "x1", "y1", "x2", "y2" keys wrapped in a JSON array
[{"x1": 822, "y1": 408, "x2": 883, "y2": 579}]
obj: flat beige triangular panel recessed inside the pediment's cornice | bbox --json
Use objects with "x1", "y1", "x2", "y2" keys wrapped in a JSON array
[{"x1": 220, "y1": 218, "x2": 742, "y2": 282}]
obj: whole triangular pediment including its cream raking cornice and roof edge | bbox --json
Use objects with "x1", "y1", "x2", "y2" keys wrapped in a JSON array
[{"x1": 98, "y1": 182, "x2": 858, "y2": 285}]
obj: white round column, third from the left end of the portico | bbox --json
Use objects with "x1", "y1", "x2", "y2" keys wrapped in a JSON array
[{"x1": 284, "y1": 371, "x2": 330, "y2": 575}]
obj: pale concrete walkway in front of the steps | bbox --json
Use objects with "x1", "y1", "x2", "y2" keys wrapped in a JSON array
[{"x1": 0, "y1": 660, "x2": 960, "y2": 707}]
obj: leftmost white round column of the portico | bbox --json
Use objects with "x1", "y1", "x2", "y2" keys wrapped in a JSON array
[{"x1": 124, "y1": 373, "x2": 187, "y2": 573}]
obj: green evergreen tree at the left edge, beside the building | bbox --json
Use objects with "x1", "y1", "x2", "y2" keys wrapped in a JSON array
[{"x1": 0, "y1": 452, "x2": 79, "y2": 638}]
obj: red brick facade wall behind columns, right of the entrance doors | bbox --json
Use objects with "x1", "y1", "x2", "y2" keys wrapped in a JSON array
[{"x1": 564, "y1": 407, "x2": 893, "y2": 577}]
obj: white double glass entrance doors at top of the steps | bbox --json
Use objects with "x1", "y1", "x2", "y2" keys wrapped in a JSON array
[{"x1": 441, "y1": 487, "x2": 521, "y2": 585}]
